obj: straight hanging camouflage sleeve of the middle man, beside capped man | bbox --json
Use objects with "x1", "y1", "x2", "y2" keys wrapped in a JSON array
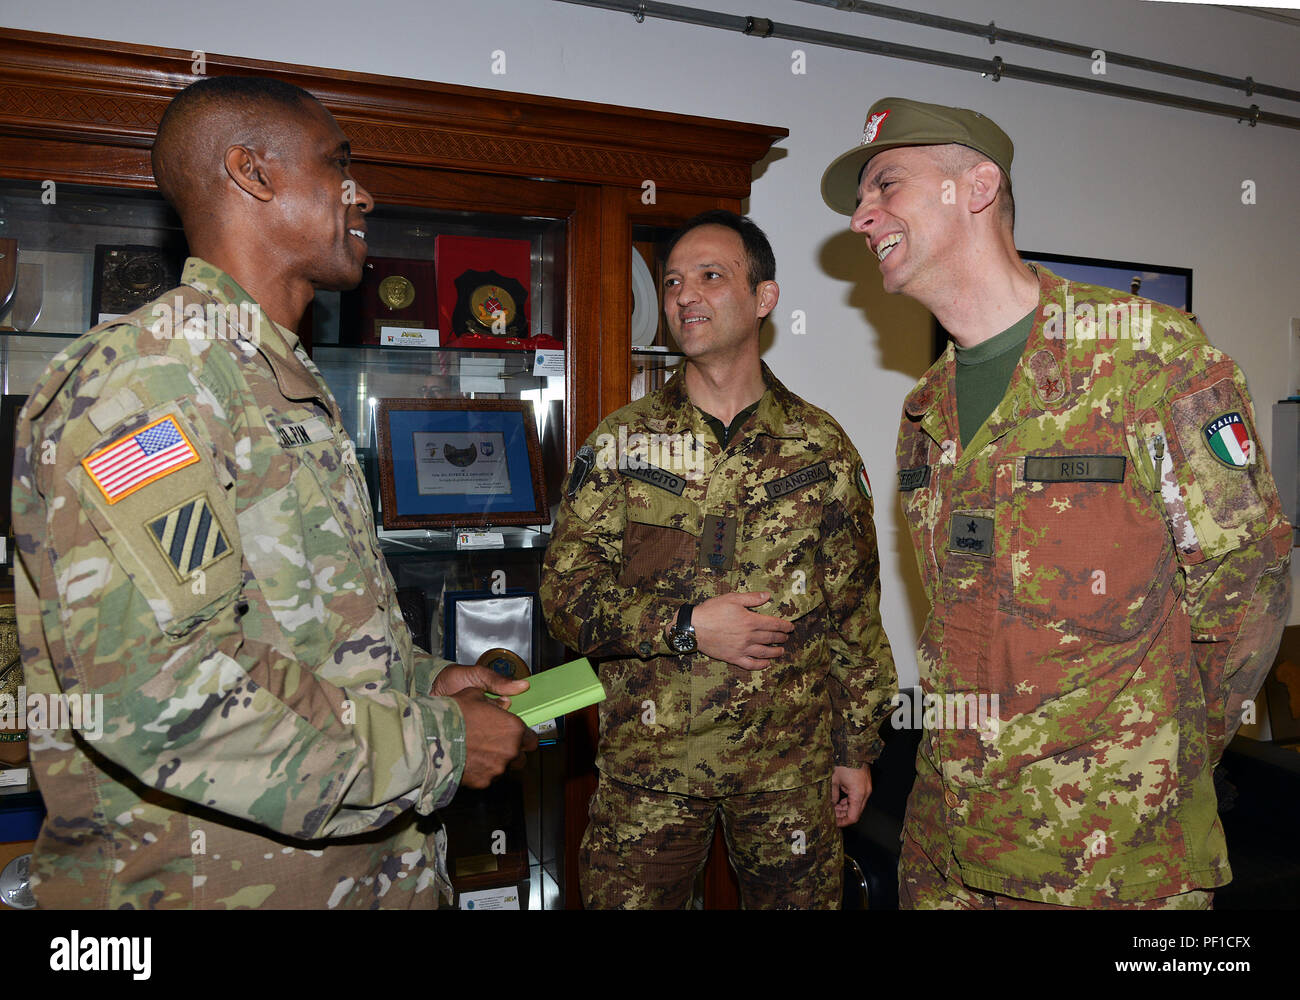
[{"x1": 819, "y1": 447, "x2": 898, "y2": 767}]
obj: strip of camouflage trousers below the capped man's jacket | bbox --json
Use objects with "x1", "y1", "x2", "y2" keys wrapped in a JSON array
[{"x1": 898, "y1": 834, "x2": 1214, "y2": 910}]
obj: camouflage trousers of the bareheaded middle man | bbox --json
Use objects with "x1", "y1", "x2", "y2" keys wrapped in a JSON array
[{"x1": 579, "y1": 774, "x2": 844, "y2": 910}]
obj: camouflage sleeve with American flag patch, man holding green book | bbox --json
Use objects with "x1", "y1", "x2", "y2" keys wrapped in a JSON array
[{"x1": 14, "y1": 358, "x2": 465, "y2": 839}]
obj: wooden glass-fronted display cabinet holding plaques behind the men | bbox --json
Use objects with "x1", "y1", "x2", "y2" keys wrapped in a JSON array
[{"x1": 0, "y1": 31, "x2": 787, "y2": 908}]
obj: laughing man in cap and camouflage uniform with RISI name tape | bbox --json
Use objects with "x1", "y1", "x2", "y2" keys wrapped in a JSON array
[{"x1": 822, "y1": 98, "x2": 1291, "y2": 909}]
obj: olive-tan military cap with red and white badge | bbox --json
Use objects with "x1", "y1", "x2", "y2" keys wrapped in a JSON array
[{"x1": 822, "y1": 98, "x2": 1015, "y2": 216}]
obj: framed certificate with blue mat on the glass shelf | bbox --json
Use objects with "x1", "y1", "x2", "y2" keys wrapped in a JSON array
[{"x1": 374, "y1": 399, "x2": 550, "y2": 529}]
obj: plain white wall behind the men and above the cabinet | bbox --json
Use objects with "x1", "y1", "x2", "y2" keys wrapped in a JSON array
[{"x1": 0, "y1": 0, "x2": 1300, "y2": 683}]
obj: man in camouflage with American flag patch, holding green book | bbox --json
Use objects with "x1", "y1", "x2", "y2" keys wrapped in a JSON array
[{"x1": 14, "y1": 78, "x2": 536, "y2": 909}]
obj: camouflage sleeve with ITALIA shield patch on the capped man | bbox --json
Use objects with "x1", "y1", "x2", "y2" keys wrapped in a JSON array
[{"x1": 1132, "y1": 342, "x2": 1291, "y2": 762}]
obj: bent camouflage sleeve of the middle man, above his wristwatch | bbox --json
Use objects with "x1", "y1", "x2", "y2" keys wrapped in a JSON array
[{"x1": 541, "y1": 425, "x2": 680, "y2": 659}]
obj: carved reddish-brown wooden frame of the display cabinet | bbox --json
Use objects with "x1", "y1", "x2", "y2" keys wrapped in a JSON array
[{"x1": 0, "y1": 30, "x2": 788, "y2": 906}]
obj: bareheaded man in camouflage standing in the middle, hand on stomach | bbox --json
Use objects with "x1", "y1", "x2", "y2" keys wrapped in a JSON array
[{"x1": 542, "y1": 212, "x2": 896, "y2": 909}]
